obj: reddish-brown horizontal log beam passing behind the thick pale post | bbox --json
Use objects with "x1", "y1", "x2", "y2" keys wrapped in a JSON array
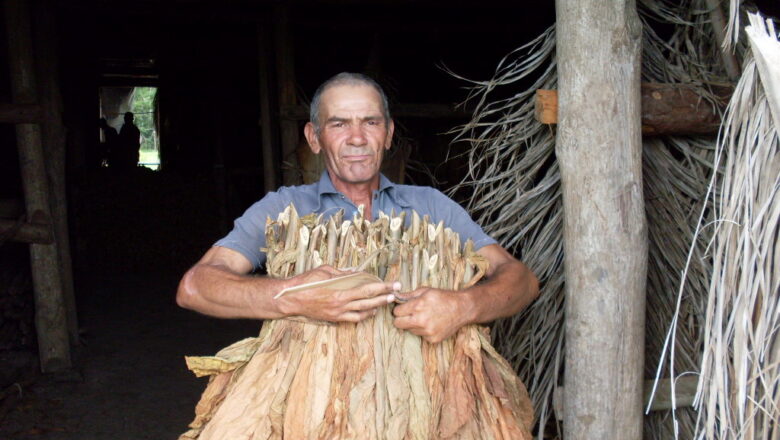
[{"x1": 534, "y1": 83, "x2": 733, "y2": 136}]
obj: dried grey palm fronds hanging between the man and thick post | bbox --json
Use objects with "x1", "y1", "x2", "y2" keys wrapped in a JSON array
[{"x1": 442, "y1": 26, "x2": 563, "y2": 438}]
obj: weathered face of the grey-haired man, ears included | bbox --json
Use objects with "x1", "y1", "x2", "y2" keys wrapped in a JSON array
[{"x1": 305, "y1": 85, "x2": 394, "y2": 185}]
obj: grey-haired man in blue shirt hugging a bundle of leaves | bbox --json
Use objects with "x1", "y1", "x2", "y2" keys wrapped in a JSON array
[{"x1": 176, "y1": 73, "x2": 538, "y2": 342}]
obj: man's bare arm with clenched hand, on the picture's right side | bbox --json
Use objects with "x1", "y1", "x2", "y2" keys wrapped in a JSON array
[{"x1": 393, "y1": 244, "x2": 539, "y2": 343}]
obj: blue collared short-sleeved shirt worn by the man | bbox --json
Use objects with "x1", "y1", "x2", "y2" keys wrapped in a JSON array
[{"x1": 214, "y1": 171, "x2": 496, "y2": 269}]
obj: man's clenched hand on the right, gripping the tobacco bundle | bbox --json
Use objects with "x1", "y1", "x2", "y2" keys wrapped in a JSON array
[{"x1": 393, "y1": 287, "x2": 473, "y2": 343}]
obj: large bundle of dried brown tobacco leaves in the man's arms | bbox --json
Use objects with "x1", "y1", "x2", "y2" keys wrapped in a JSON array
[{"x1": 180, "y1": 206, "x2": 533, "y2": 440}]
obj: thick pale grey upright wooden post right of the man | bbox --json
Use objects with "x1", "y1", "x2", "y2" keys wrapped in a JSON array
[{"x1": 556, "y1": 0, "x2": 647, "y2": 440}]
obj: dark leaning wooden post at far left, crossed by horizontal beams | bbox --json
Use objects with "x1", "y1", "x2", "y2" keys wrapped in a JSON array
[{"x1": 5, "y1": 0, "x2": 71, "y2": 373}]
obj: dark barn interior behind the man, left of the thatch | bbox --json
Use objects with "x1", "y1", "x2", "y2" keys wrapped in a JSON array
[{"x1": 0, "y1": 0, "x2": 555, "y2": 439}]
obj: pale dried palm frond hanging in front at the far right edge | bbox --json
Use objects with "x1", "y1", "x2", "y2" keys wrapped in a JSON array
[{"x1": 696, "y1": 15, "x2": 780, "y2": 439}]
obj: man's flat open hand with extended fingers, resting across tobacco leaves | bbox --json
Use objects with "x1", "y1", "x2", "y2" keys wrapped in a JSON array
[{"x1": 276, "y1": 266, "x2": 400, "y2": 322}]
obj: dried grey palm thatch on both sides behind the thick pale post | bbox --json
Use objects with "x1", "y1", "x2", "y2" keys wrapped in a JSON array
[{"x1": 444, "y1": 0, "x2": 760, "y2": 439}]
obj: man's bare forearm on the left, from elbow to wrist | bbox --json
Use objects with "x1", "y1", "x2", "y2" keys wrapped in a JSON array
[{"x1": 176, "y1": 264, "x2": 286, "y2": 319}]
